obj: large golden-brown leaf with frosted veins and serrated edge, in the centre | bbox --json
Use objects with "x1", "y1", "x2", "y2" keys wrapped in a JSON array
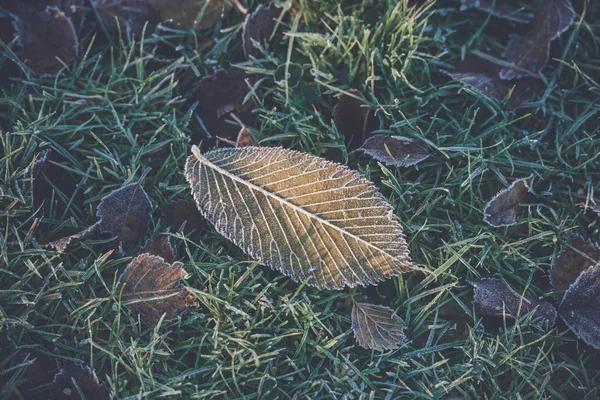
[{"x1": 185, "y1": 146, "x2": 418, "y2": 289}]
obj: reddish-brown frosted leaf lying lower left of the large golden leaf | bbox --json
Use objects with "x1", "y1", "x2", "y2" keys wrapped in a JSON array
[{"x1": 117, "y1": 254, "x2": 195, "y2": 326}]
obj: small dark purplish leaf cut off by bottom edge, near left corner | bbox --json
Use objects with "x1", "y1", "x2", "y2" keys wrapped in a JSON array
[{"x1": 54, "y1": 363, "x2": 110, "y2": 400}]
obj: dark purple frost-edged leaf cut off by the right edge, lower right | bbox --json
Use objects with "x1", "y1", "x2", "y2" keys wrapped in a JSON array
[{"x1": 559, "y1": 264, "x2": 600, "y2": 350}]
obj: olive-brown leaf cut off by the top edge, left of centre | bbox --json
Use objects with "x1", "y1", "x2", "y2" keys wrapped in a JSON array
[{"x1": 156, "y1": 0, "x2": 230, "y2": 30}]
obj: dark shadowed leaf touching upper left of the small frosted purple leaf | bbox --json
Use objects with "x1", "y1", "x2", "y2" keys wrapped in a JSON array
[{"x1": 333, "y1": 89, "x2": 379, "y2": 150}]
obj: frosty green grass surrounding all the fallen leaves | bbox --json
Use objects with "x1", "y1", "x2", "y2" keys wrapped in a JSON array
[{"x1": 0, "y1": 0, "x2": 600, "y2": 399}]
